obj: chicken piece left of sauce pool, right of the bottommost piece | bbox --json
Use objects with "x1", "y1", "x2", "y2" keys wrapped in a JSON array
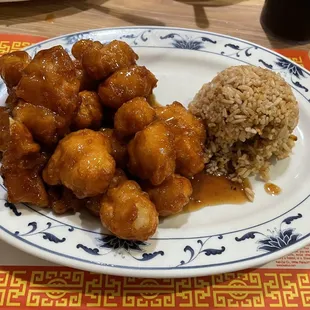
[{"x1": 145, "y1": 174, "x2": 193, "y2": 216}]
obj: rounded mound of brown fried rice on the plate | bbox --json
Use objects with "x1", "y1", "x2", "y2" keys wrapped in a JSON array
[{"x1": 189, "y1": 66, "x2": 299, "y2": 200}]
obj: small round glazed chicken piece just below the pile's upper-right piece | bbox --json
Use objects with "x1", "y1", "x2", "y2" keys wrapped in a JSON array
[{"x1": 114, "y1": 97, "x2": 156, "y2": 137}]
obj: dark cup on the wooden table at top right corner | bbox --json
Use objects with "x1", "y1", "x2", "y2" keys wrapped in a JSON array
[{"x1": 261, "y1": 0, "x2": 310, "y2": 42}]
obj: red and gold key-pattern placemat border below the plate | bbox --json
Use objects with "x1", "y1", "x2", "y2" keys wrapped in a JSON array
[{"x1": 0, "y1": 266, "x2": 310, "y2": 310}]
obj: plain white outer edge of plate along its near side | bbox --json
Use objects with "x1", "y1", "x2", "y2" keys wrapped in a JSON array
[{"x1": 0, "y1": 225, "x2": 310, "y2": 279}]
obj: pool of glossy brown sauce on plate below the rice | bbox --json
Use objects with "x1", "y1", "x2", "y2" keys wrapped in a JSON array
[{"x1": 183, "y1": 172, "x2": 248, "y2": 212}]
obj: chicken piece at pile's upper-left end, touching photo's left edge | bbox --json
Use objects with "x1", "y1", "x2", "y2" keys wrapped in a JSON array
[{"x1": 0, "y1": 51, "x2": 31, "y2": 88}]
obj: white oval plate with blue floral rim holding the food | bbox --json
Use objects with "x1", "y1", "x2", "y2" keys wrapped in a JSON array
[{"x1": 0, "y1": 27, "x2": 310, "y2": 278}]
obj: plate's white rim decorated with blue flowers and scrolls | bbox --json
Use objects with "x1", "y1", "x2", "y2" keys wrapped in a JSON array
[{"x1": 0, "y1": 27, "x2": 310, "y2": 277}]
